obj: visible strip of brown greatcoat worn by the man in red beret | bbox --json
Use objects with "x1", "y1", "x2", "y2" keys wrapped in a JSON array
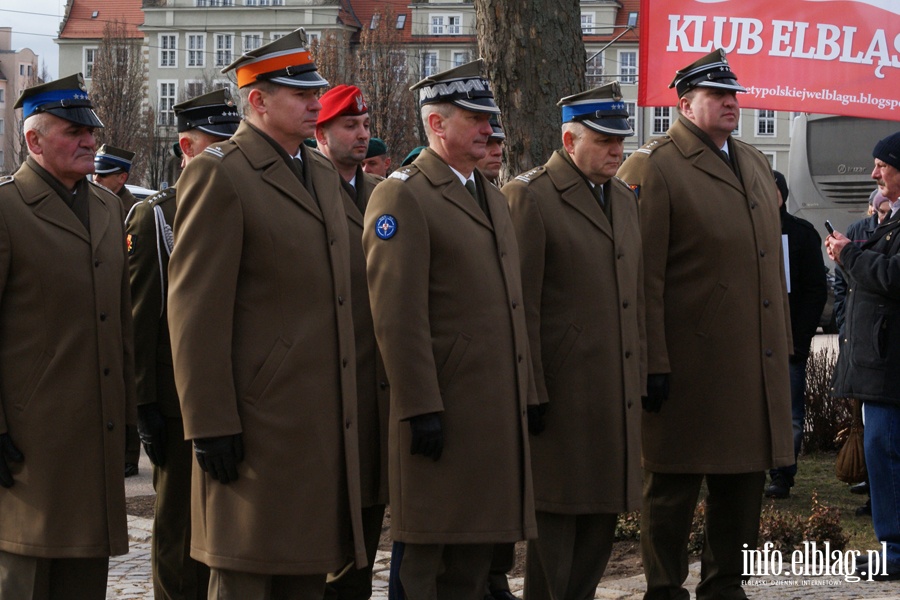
[{"x1": 344, "y1": 167, "x2": 390, "y2": 507}]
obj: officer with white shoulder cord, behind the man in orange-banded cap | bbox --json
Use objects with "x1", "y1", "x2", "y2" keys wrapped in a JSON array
[{"x1": 125, "y1": 89, "x2": 241, "y2": 600}]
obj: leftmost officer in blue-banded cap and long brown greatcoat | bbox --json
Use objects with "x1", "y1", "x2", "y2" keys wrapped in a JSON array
[{"x1": 0, "y1": 73, "x2": 135, "y2": 600}]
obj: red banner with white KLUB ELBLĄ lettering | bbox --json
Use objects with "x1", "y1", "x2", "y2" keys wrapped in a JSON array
[{"x1": 638, "y1": 0, "x2": 900, "y2": 121}]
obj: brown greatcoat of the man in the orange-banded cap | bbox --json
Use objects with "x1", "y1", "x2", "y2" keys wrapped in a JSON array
[{"x1": 169, "y1": 122, "x2": 365, "y2": 575}]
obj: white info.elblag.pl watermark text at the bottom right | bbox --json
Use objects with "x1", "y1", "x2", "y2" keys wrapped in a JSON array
[{"x1": 741, "y1": 542, "x2": 887, "y2": 585}]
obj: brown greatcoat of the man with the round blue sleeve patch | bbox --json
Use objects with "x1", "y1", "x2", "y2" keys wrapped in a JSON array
[{"x1": 363, "y1": 150, "x2": 537, "y2": 544}]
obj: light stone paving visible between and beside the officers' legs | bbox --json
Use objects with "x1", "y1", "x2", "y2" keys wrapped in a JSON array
[{"x1": 106, "y1": 517, "x2": 900, "y2": 600}]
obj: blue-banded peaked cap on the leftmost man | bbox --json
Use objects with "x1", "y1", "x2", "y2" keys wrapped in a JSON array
[{"x1": 13, "y1": 73, "x2": 103, "y2": 127}]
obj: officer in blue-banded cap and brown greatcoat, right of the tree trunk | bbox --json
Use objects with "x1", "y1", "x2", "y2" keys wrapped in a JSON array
[{"x1": 503, "y1": 82, "x2": 646, "y2": 600}]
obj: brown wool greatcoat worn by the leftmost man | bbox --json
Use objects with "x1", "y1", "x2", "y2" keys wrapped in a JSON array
[{"x1": 0, "y1": 164, "x2": 136, "y2": 556}]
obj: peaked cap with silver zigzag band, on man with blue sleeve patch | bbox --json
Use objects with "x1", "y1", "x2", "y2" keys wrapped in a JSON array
[{"x1": 409, "y1": 58, "x2": 500, "y2": 114}]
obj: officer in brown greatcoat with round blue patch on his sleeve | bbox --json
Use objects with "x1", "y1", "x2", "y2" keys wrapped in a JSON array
[{"x1": 363, "y1": 60, "x2": 536, "y2": 600}]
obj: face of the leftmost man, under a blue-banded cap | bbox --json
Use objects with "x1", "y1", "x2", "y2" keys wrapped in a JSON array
[{"x1": 28, "y1": 115, "x2": 97, "y2": 187}]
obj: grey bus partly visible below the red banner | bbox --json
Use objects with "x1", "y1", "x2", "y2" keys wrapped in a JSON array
[{"x1": 787, "y1": 113, "x2": 900, "y2": 247}]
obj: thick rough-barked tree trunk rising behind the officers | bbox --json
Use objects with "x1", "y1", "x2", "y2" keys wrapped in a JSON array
[{"x1": 475, "y1": 0, "x2": 585, "y2": 182}]
